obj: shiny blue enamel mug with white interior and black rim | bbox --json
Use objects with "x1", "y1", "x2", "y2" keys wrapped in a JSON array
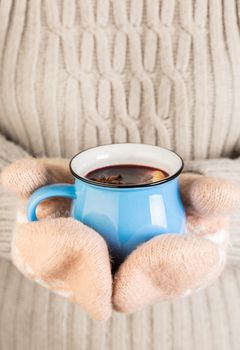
[{"x1": 27, "y1": 143, "x2": 185, "y2": 260}]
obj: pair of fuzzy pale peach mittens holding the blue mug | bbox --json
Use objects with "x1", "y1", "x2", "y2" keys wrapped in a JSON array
[{"x1": 2, "y1": 158, "x2": 240, "y2": 319}]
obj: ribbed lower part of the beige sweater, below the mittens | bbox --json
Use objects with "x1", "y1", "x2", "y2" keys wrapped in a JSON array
[{"x1": 0, "y1": 260, "x2": 240, "y2": 350}]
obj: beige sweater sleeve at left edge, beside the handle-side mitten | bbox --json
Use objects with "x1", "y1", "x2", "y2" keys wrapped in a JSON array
[{"x1": 0, "y1": 134, "x2": 28, "y2": 259}]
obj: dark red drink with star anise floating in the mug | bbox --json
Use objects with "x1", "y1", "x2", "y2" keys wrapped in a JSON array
[{"x1": 85, "y1": 164, "x2": 169, "y2": 185}]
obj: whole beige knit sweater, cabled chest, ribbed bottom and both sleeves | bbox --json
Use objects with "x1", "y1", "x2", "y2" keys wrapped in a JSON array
[{"x1": 0, "y1": 0, "x2": 240, "y2": 350}]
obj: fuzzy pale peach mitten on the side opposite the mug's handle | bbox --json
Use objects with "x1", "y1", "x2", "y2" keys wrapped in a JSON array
[{"x1": 113, "y1": 174, "x2": 240, "y2": 313}]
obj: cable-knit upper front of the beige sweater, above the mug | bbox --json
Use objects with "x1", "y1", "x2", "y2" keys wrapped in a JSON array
[{"x1": 0, "y1": 0, "x2": 240, "y2": 159}]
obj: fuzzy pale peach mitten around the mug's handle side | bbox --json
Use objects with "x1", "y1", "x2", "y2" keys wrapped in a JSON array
[{"x1": 2, "y1": 158, "x2": 112, "y2": 319}]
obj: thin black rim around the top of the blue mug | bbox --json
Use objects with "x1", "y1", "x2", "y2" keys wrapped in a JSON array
[{"x1": 69, "y1": 142, "x2": 184, "y2": 189}]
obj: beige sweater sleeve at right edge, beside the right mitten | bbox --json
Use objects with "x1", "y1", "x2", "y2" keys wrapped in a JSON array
[{"x1": 184, "y1": 158, "x2": 240, "y2": 265}]
